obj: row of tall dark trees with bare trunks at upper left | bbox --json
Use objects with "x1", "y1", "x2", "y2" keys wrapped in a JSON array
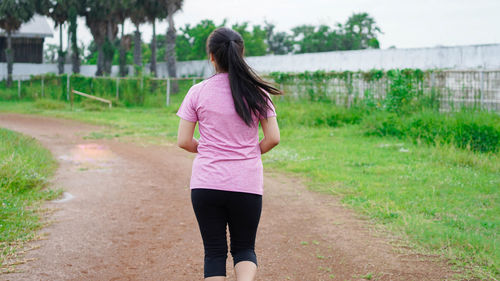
[{"x1": 0, "y1": 0, "x2": 183, "y2": 86}]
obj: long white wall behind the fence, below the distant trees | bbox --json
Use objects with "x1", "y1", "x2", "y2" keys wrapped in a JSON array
[{"x1": 0, "y1": 44, "x2": 500, "y2": 79}]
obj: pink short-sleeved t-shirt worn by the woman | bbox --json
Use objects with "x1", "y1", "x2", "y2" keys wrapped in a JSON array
[{"x1": 177, "y1": 73, "x2": 276, "y2": 195}]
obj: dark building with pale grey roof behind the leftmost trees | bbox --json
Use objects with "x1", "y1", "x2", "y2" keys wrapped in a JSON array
[{"x1": 0, "y1": 15, "x2": 52, "y2": 63}]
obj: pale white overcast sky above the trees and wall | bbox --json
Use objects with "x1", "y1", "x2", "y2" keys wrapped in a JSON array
[{"x1": 46, "y1": 0, "x2": 500, "y2": 49}]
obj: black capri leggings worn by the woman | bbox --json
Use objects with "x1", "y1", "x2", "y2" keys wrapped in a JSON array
[{"x1": 191, "y1": 189, "x2": 262, "y2": 278}]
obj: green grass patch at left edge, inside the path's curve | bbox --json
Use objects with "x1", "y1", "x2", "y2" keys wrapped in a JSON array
[{"x1": 0, "y1": 129, "x2": 60, "y2": 272}]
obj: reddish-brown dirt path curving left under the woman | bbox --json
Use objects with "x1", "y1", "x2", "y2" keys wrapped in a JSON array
[{"x1": 0, "y1": 114, "x2": 454, "y2": 281}]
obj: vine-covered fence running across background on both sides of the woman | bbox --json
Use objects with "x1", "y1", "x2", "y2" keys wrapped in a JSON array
[{"x1": 0, "y1": 70, "x2": 500, "y2": 112}]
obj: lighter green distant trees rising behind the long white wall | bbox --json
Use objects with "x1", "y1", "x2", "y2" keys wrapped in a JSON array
[{"x1": 50, "y1": 13, "x2": 381, "y2": 65}]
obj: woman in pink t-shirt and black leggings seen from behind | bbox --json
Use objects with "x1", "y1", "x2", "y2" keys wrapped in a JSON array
[{"x1": 177, "y1": 27, "x2": 281, "y2": 281}]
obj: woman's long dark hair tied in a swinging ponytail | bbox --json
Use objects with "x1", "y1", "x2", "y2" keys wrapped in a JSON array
[{"x1": 207, "y1": 27, "x2": 282, "y2": 126}]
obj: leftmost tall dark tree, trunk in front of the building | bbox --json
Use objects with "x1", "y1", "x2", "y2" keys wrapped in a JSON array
[{"x1": 0, "y1": 0, "x2": 35, "y2": 87}]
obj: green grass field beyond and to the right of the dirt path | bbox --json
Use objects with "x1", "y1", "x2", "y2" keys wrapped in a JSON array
[{"x1": 0, "y1": 95, "x2": 500, "y2": 279}]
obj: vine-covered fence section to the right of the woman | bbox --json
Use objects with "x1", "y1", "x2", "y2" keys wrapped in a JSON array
[{"x1": 271, "y1": 70, "x2": 500, "y2": 111}]
